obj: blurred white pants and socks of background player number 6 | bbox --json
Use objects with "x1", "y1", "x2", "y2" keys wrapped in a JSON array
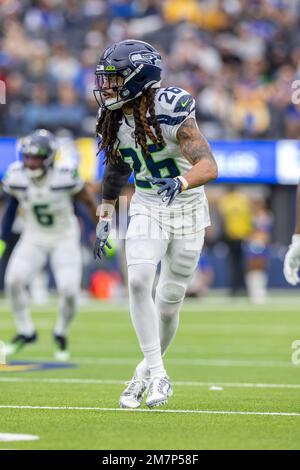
[{"x1": 5, "y1": 237, "x2": 82, "y2": 336}]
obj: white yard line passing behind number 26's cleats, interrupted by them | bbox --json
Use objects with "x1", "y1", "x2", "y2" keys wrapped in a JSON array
[{"x1": 0, "y1": 377, "x2": 300, "y2": 389}]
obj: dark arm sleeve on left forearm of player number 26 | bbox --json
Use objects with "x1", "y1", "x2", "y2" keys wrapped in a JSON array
[{"x1": 102, "y1": 159, "x2": 131, "y2": 200}]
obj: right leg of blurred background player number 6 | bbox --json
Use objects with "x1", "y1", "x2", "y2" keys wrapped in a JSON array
[{"x1": 51, "y1": 239, "x2": 82, "y2": 361}]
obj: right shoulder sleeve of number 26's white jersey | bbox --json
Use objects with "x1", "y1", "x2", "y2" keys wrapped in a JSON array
[{"x1": 162, "y1": 90, "x2": 196, "y2": 142}]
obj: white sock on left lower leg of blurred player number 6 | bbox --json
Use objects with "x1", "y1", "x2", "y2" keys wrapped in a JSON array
[{"x1": 7, "y1": 285, "x2": 35, "y2": 336}]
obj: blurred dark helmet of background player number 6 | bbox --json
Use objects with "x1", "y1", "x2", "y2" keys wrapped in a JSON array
[{"x1": 20, "y1": 129, "x2": 57, "y2": 178}]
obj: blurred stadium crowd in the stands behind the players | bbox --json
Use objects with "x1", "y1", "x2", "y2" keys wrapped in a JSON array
[{"x1": 0, "y1": 0, "x2": 300, "y2": 139}]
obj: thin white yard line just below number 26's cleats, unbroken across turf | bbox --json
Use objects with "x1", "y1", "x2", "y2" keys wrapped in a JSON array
[{"x1": 0, "y1": 405, "x2": 300, "y2": 417}]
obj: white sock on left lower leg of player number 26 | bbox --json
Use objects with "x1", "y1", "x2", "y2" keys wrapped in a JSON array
[{"x1": 128, "y1": 263, "x2": 166, "y2": 377}]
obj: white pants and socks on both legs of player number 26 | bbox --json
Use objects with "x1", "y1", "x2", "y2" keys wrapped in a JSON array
[{"x1": 126, "y1": 215, "x2": 205, "y2": 376}]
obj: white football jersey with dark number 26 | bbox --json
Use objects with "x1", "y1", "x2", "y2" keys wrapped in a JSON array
[{"x1": 118, "y1": 87, "x2": 210, "y2": 233}]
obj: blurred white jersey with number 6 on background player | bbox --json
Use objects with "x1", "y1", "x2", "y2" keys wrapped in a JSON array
[{"x1": 3, "y1": 161, "x2": 84, "y2": 246}]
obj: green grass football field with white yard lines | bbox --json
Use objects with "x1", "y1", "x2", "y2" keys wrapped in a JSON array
[{"x1": 0, "y1": 297, "x2": 300, "y2": 450}]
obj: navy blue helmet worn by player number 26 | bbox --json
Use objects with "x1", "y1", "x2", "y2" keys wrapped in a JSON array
[{"x1": 94, "y1": 39, "x2": 162, "y2": 110}]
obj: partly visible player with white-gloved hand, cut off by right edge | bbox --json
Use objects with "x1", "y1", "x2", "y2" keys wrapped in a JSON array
[{"x1": 283, "y1": 183, "x2": 300, "y2": 286}]
